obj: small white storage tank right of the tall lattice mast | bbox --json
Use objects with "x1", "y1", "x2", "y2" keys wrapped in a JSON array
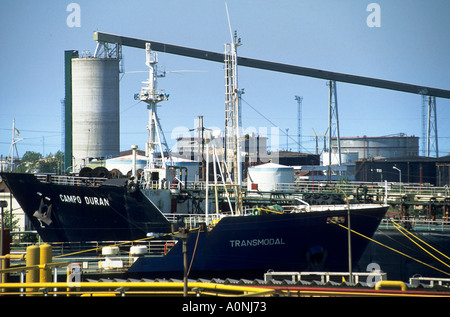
[{"x1": 247, "y1": 163, "x2": 294, "y2": 191}]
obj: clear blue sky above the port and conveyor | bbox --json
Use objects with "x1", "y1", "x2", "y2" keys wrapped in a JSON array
[{"x1": 0, "y1": 0, "x2": 450, "y2": 156}]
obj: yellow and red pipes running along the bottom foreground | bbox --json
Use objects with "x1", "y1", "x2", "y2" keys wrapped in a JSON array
[{"x1": 0, "y1": 279, "x2": 450, "y2": 297}]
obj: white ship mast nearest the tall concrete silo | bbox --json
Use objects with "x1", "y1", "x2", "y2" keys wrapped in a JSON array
[{"x1": 135, "y1": 43, "x2": 172, "y2": 169}]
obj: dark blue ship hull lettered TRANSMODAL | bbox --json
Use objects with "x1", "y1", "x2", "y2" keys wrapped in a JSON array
[{"x1": 128, "y1": 205, "x2": 387, "y2": 279}]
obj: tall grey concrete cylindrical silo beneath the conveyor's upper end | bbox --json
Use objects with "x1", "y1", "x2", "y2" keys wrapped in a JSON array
[{"x1": 72, "y1": 58, "x2": 120, "y2": 171}]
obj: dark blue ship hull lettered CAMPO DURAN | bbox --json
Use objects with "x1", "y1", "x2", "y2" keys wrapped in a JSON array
[{"x1": 1, "y1": 173, "x2": 171, "y2": 242}]
